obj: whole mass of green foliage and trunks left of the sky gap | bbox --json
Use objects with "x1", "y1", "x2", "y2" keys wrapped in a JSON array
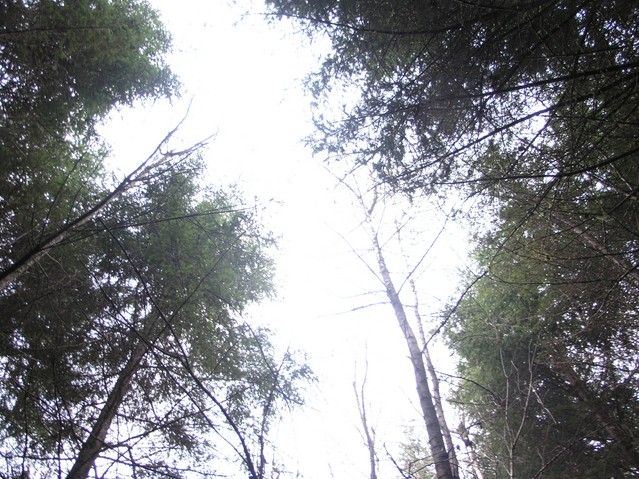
[{"x1": 0, "y1": 0, "x2": 308, "y2": 478}]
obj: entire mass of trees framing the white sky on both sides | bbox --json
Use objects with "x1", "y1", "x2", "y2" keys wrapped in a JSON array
[{"x1": 0, "y1": 0, "x2": 639, "y2": 479}]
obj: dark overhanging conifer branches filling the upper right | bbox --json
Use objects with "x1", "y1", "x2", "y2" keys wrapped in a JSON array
[{"x1": 268, "y1": 0, "x2": 639, "y2": 197}]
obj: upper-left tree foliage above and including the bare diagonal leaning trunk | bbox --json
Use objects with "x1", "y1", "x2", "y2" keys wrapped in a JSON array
[{"x1": 0, "y1": 0, "x2": 178, "y2": 289}]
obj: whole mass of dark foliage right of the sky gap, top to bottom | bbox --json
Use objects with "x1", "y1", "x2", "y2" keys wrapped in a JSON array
[{"x1": 267, "y1": 0, "x2": 639, "y2": 478}]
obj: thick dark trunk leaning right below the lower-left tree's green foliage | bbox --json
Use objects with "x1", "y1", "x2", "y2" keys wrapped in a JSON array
[{"x1": 67, "y1": 340, "x2": 149, "y2": 479}]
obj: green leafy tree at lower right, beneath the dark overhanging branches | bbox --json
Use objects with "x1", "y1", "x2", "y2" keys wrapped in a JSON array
[{"x1": 448, "y1": 208, "x2": 639, "y2": 478}]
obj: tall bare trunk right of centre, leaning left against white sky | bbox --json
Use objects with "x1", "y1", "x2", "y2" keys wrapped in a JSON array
[{"x1": 372, "y1": 235, "x2": 455, "y2": 479}]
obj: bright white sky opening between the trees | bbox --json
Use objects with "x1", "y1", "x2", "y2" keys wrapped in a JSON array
[{"x1": 104, "y1": 0, "x2": 470, "y2": 479}]
